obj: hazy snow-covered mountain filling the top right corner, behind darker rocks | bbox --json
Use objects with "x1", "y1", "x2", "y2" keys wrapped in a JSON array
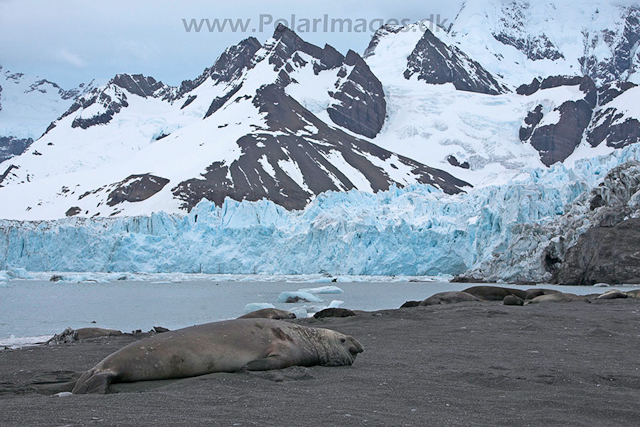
[{"x1": 447, "y1": 0, "x2": 640, "y2": 87}]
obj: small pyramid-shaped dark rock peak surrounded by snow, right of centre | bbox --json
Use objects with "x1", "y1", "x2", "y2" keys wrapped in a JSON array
[{"x1": 404, "y1": 30, "x2": 508, "y2": 95}]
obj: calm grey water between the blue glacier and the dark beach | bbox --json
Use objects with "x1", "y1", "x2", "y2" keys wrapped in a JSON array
[{"x1": 0, "y1": 280, "x2": 620, "y2": 345}]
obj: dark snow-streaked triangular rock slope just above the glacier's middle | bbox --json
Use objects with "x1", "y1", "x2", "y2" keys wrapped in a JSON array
[{"x1": 172, "y1": 84, "x2": 469, "y2": 209}]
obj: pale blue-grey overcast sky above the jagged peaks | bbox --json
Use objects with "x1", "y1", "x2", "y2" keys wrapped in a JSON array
[{"x1": 0, "y1": 0, "x2": 463, "y2": 88}]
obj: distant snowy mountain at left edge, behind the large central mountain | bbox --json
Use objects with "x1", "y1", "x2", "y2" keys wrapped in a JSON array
[{"x1": 0, "y1": 65, "x2": 95, "y2": 163}]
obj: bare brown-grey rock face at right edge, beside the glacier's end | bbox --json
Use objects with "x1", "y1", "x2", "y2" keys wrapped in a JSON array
[{"x1": 555, "y1": 218, "x2": 640, "y2": 285}]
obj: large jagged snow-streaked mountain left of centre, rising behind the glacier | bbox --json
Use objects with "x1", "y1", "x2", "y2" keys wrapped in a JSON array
[{"x1": 0, "y1": 26, "x2": 470, "y2": 219}]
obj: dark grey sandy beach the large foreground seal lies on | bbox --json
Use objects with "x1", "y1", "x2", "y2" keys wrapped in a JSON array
[{"x1": 0, "y1": 299, "x2": 640, "y2": 426}]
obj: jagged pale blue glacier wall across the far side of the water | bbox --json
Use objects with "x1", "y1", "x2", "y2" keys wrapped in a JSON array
[{"x1": 0, "y1": 145, "x2": 640, "y2": 280}]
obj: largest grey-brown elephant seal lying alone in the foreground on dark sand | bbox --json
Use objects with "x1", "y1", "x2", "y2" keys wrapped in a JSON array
[{"x1": 73, "y1": 319, "x2": 364, "y2": 394}]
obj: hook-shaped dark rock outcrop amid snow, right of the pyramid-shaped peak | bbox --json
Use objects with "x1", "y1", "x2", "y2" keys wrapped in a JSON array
[{"x1": 518, "y1": 76, "x2": 597, "y2": 166}]
